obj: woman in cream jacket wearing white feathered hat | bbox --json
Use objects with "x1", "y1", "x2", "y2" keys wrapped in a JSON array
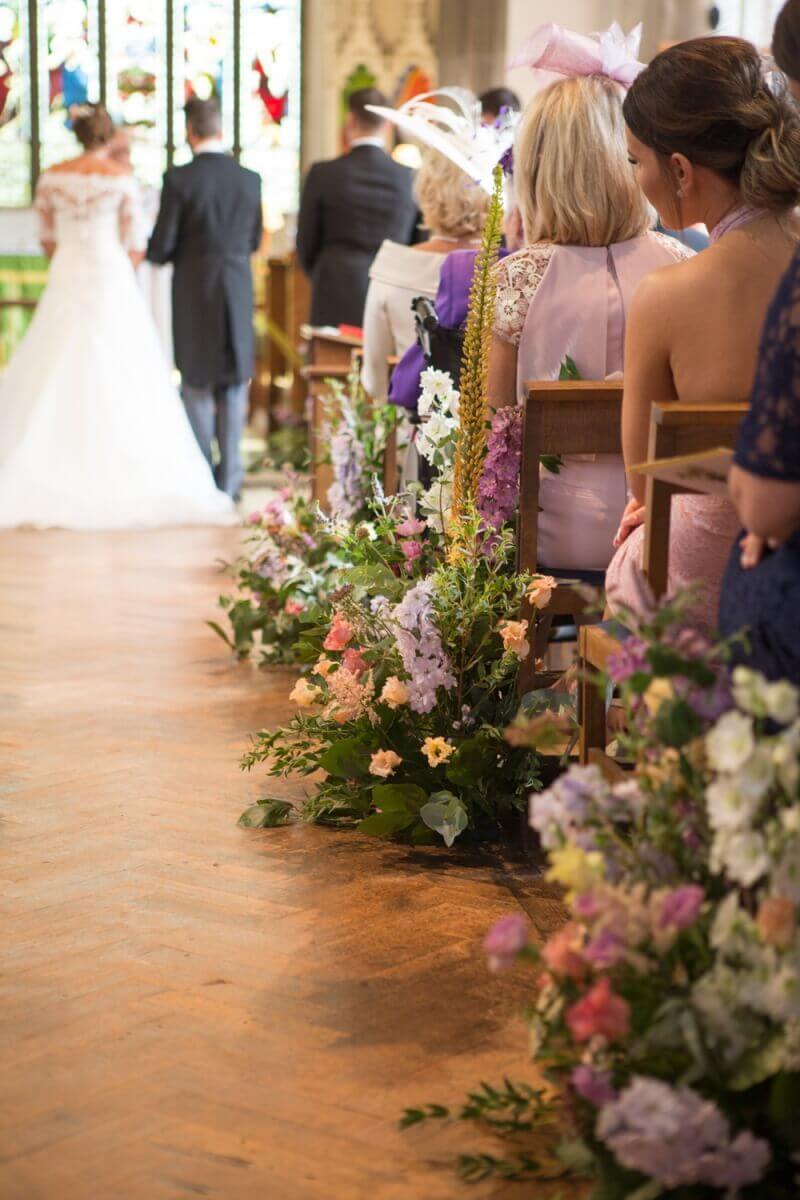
[{"x1": 361, "y1": 88, "x2": 511, "y2": 401}]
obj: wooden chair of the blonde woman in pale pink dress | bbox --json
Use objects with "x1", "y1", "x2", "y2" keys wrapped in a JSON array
[{"x1": 517, "y1": 380, "x2": 622, "y2": 695}]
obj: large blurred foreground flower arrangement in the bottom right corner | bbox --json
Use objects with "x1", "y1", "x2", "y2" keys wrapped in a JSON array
[{"x1": 413, "y1": 588, "x2": 800, "y2": 1200}]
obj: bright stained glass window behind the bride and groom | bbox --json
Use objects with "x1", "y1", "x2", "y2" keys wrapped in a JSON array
[{"x1": 0, "y1": 0, "x2": 302, "y2": 228}]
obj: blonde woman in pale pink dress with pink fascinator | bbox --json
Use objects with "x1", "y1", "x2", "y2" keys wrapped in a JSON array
[{"x1": 489, "y1": 29, "x2": 691, "y2": 571}]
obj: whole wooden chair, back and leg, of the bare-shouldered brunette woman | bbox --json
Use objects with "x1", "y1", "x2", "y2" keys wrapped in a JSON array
[{"x1": 578, "y1": 403, "x2": 747, "y2": 775}]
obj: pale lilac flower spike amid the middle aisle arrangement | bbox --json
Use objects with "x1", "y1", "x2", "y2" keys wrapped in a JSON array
[{"x1": 390, "y1": 578, "x2": 456, "y2": 713}]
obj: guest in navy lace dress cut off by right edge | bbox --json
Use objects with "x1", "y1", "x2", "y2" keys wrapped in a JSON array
[{"x1": 720, "y1": 0, "x2": 800, "y2": 686}]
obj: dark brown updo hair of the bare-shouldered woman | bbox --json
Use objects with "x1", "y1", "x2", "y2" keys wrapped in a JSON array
[{"x1": 624, "y1": 37, "x2": 800, "y2": 212}]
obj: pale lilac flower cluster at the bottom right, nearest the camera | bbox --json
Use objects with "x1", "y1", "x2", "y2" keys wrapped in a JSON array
[{"x1": 596, "y1": 1076, "x2": 771, "y2": 1196}]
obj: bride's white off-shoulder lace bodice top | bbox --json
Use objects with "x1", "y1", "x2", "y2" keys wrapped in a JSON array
[{"x1": 34, "y1": 170, "x2": 148, "y2": 251}]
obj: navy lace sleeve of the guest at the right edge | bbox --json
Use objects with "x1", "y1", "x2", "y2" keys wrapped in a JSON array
[{"x1": 735, "y1": 251, "x2": 800, "y2": 482}]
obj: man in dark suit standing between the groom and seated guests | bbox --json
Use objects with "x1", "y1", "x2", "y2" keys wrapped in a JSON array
[{"x1": 297, "y1": 88, "x2": 417, "y2": 325}]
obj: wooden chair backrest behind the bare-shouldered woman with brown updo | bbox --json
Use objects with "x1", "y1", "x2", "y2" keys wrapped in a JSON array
[{"x1": 642, "y1": 402, "x2": 748, "y2": 598}]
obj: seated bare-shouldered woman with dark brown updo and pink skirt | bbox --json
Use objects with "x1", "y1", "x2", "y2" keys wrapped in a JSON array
[{"x1": 607, "y1": 37, "x2": 800, "y2": 626}]
